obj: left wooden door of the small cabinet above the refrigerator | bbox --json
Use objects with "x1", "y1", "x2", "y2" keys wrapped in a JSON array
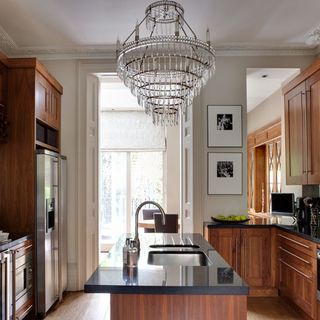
[{"x1": 35, "y1": 73, "x2": 50, "y2": 123}]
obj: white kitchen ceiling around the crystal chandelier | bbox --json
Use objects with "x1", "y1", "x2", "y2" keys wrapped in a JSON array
[{"x1": 0, "y1": 0, "x2": 320, "y2": 57}]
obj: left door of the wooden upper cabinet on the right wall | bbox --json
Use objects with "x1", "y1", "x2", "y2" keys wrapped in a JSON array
[{"x1": 285, "y1": 82, "x2": 307, "y2": 184}]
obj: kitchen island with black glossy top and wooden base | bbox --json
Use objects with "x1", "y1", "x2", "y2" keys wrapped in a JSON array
[{"x1": 84, "y1": 233, "x2": 248, "y2": 320}]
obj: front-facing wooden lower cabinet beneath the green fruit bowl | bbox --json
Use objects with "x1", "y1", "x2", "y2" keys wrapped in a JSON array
[{"x1": 206, "y1": 227, "x2": 277, "y2": 296}]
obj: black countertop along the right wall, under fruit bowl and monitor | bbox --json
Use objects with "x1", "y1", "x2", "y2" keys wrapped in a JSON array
[{"x1": 204, "y1": 216, "x2": 320, "y2": 243}]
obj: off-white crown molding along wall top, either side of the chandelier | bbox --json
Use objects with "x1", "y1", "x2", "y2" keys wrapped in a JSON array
[{"x1": 0, "y1": 41, "x2": 320, "y2": 60}]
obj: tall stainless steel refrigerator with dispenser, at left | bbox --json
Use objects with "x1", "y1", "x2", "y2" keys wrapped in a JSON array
[{"x1": 36, "y1": 150, "x2": 67, "y2": 316}]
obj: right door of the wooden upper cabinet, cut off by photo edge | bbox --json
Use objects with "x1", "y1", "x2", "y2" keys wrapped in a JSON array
[{"x1": 306, "y1": 70, "x2": 320, "y2": 184}]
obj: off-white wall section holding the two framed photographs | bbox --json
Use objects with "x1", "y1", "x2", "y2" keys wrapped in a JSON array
[{"x1": 193, "y1": 56, "x2": 315, "y2": 232}]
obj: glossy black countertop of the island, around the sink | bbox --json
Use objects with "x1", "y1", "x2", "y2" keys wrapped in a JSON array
[{"x1": 84, "y1": 233, "x2": 249, "y2": 295}]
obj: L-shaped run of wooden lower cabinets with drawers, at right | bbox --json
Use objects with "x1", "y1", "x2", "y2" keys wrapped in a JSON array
[{"x1": 205, "y1": 227, "x2": 320, "y2": 320}]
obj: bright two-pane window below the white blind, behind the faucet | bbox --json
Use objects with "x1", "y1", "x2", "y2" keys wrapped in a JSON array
[{"x1": 100, "y1": 150, "x2": 163, "y2": 245}]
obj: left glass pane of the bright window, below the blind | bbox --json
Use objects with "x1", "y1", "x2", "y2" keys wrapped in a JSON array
[{"x1": 99, "y1": 151, "x2": 127, "y2": 244}]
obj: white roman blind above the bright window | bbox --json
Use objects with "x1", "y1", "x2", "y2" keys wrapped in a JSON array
[{"x1": 100, "y1": 111, "x2": 165, "y2": 150}]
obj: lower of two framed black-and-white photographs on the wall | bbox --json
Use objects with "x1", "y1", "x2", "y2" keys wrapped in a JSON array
[{"x1": 208, "y1": 152, "x2": 242, "y2": 194}]
